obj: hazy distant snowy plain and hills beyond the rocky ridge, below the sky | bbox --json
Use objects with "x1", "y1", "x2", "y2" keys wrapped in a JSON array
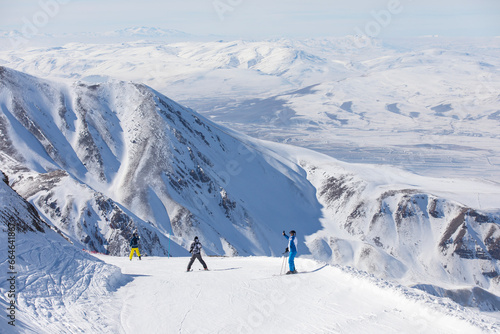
[{"x1": 0, "y1": 34, "x2": 500, "y2": 182}]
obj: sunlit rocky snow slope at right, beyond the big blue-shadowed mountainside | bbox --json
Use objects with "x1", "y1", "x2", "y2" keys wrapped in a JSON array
[{"x1": 304, "y1": 160, "x2": 500, "y2": 309}]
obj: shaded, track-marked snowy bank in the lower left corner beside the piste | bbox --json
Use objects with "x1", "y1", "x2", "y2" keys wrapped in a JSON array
[{"x1": 0, "y1": 174, "x2": 131, "y2": 334}]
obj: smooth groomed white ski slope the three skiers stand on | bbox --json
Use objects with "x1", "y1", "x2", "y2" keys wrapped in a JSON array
[{"x1": 93, "y1": 255, "x2": 500, "y2": 334}]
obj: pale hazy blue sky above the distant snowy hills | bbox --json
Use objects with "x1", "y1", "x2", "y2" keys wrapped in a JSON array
[{"x1": 0, "y1": 0, "x2": 500, "y2": 38}]
